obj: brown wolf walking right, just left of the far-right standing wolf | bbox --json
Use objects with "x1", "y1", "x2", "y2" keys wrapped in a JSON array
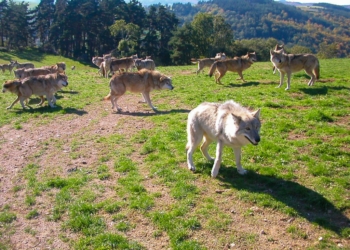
[{"x1": 209, "y1": 52, "x2": 256, "y2": 84}]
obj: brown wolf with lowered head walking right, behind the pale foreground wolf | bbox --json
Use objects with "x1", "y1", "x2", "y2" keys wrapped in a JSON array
[{"x1": 104, "y1": 69, "x2": 174, "y2": 111}]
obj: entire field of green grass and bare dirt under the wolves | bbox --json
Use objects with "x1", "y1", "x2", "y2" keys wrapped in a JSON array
[{"x1": 0, "y1": 51, "x2": 350, "y2": 249}]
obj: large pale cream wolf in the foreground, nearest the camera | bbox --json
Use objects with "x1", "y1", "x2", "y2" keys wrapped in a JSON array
[{"x1": 186, "y1": 100, "x2": 261, "y2": 177}]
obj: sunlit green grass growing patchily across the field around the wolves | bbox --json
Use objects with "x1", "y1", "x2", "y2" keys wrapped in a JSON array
[{"x1": 0, "y1": 49, "x2": 350, "y2": 249}]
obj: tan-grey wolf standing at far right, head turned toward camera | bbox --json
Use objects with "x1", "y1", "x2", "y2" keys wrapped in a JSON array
[{"x1": 270, "y1": 50, "x2": 320, "y2": 90}]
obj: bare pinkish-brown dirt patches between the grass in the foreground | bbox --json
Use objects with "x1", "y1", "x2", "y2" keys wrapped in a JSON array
[{"x1": 0, "y1": 94, "x2": 350, "y2": 249}]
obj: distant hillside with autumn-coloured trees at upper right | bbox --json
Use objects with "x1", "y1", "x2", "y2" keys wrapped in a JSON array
[{"x1": 172, "y1": 0, "x2": 350, "y2": 57}]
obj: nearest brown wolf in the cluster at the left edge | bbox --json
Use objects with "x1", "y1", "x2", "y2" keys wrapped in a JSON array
[{"x1": 2, "y1": 73, "x2": 68, "y2": 109}]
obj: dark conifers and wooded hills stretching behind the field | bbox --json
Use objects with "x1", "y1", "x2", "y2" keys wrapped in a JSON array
[{"x1": 0, "y1": 0, "x2": 350, "y2": 65}]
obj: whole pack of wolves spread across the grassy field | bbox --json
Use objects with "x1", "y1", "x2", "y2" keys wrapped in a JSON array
[{"x1": 0, "y1": 45, "x2": 320, "y2": 177}]
